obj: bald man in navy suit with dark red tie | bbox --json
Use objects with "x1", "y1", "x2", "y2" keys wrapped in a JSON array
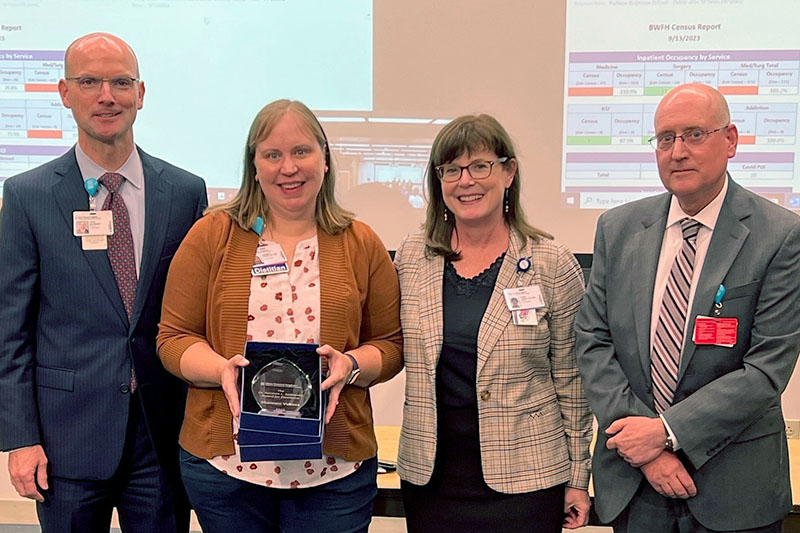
[{"x1": 0, "y1": 34, "x2": 207, "y2": 533}]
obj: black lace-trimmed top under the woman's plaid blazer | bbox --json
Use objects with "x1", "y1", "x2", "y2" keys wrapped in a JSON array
[{"x1": 436, "y1": 252, "x2": 506, "y2": 407}]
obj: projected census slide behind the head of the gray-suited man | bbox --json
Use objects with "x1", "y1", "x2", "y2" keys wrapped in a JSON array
[{"x1": 561, "y1": 0, "x2": 800, "y2": 209}]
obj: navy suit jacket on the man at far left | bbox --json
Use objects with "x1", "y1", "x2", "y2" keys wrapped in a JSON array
[{"x1": 0, "y1": 147, "x2": 208, "y2": 480}]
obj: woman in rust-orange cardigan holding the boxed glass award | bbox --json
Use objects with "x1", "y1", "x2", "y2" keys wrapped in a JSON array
[{"x1": 158, "y1": 100, "x2": 403, "y2": 533}]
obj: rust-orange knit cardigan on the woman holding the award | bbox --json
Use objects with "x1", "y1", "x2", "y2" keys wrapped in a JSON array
[{"x1": 158, "y1": 213, "x2": 403, "y2": 461}]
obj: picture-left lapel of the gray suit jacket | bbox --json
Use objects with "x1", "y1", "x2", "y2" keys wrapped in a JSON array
[{"x1": 628, "y1": 201, "x2": 670, "y2": 384}]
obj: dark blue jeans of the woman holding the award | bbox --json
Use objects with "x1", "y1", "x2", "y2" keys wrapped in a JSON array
[{"x1": 181, "y1": 449, "x2": 378, "y2": 533}]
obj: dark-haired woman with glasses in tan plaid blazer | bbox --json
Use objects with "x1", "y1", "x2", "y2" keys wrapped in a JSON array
[{"x1": 395, "y1": 115, "x2": 592, "y2": 533}]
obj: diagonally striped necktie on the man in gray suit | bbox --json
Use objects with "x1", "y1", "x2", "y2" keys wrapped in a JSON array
[{"x1": 650, "y1": 218, "x2": 702, "y2": 413}]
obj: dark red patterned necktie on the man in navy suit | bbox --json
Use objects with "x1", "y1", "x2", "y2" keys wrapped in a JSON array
[{"x1": 98, "y1": 172, "x2": 138, "y2": 393}]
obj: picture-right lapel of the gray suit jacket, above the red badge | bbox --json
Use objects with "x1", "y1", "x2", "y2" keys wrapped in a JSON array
[{"x1": 678, "y1": 179, "x2": 750, "y2": 384}]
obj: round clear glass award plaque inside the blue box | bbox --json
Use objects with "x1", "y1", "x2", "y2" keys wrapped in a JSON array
[{"x1": 250, "y1": 358, "x2": 313, "y2": 417}]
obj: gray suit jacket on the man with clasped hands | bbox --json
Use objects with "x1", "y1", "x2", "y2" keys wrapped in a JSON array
[{"x1": 576, "y1": 180, "x2": 800, "y2": 530}]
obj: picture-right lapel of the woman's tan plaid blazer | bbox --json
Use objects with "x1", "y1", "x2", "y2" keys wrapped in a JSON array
[{"x1": 477, "y1": 230, "x2": 536, "y2": 375}]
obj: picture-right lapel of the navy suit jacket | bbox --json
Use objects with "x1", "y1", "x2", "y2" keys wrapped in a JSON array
[{"x1": 131, "y1": 147, "x2": 172, "y2": 327}]
